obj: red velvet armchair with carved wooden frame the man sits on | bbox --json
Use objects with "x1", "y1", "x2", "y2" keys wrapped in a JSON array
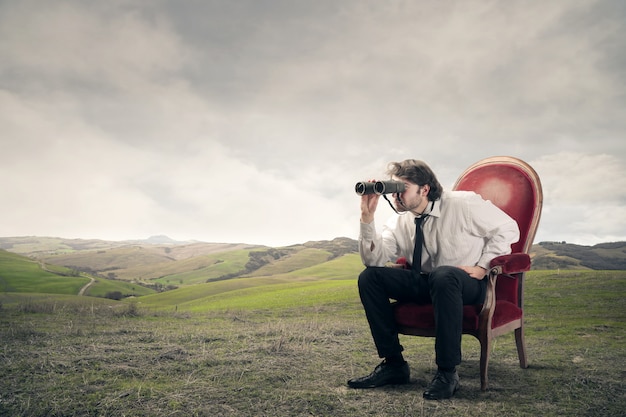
[{"x1": 394, "y1": 156, "x2": 543, "y2": 391}]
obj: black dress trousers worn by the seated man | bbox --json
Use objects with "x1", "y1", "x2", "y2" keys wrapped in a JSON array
[{"x1": 359, "y1": 266, "x2": 486, "y2": 368}]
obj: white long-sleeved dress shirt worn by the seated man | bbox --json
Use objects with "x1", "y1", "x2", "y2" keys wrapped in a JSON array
[{"x1": 359, "y1": 191, "x2": 519, "y2": 272}]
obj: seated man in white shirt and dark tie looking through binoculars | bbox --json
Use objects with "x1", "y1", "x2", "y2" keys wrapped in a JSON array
[{"x1": 348, "y1": 159, "x2": 519, "y2": 400}]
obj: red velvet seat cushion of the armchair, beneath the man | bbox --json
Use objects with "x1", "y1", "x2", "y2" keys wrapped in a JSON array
[{"x1": 394, "y1": 301, "x2": 522, "y2": 330}]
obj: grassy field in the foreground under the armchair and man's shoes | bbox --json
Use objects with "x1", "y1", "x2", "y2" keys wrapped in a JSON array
[{"x1": 0, "y1": 268, "x2": 626, "y2": 417}]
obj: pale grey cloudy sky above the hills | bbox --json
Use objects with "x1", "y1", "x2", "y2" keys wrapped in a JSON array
[{"x1": 0, "y1": 0, "x2": 626, "y2": 246}]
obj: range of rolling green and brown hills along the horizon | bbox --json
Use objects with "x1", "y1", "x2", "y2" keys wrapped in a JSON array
[{"x1": 0, "y1": 237, "x2": 626, "y2": 302}]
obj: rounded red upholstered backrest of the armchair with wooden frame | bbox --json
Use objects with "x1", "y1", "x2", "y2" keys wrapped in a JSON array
[{"x1": 453, "y1": 156, "x2": 543, "y2": 253}]
